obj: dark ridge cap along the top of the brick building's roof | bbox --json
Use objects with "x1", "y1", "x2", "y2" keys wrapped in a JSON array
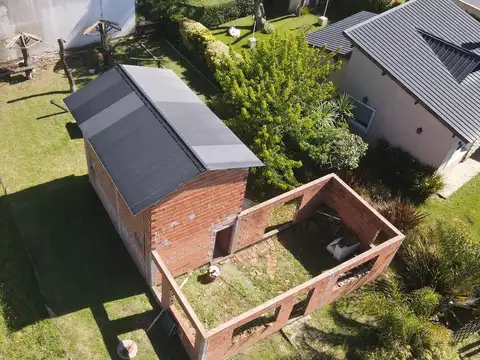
[{"x1": 115, "y1": 64, "x2": 208, "y2": 171}]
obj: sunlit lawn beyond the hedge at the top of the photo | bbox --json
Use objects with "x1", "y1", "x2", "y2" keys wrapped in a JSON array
[{"x1": 212, "y1": 14, "x2": 320, "y2": 50}]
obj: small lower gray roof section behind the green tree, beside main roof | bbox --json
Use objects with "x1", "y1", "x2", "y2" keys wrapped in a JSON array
[{"x1": 305, "y1": 11, "x2": 376, "y2": 56}]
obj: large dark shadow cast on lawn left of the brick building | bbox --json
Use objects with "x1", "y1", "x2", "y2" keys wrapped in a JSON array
[{"x1": 0, "y1": 176, "x2": 186, "y2": 359}]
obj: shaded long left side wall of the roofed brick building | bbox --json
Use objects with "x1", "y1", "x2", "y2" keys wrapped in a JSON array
[{"x1": 85, "y1": 140, "x2": 151, "y2": 283}]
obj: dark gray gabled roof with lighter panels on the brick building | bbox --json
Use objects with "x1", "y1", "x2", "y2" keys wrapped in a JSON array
[{"x1": 65, "y1": 65, "x2": 263, "y2": 214}]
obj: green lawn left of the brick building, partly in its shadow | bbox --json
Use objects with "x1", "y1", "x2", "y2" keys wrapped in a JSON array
[{"x1": 0, "y1": 37, "x2": 216, "y2": 359}]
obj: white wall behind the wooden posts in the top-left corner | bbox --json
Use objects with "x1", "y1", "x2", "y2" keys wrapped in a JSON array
[{"x1": 0, "y1": 0, "x2": 135, "y2": 61}]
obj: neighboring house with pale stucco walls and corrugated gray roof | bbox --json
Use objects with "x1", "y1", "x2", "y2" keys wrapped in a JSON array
[{"x1": 307, "y1": 0, "x2": 480, "y2": 171}]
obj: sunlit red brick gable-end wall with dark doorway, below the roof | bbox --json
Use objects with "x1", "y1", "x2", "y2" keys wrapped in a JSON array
[{"x1": 151, "y1": 169, "x2": 248, "y2": 282}]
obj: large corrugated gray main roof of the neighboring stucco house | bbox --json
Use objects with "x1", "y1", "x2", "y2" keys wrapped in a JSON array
[{"x1": 345, "y1": 0, "x2": 480, "y2": 142}]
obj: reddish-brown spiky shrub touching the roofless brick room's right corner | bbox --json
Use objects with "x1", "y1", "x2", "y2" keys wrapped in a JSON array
[{"x1": 375, "y1": 197, "x2": 426, "y2": 233}]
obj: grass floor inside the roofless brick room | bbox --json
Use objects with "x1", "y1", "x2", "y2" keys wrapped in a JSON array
[{"x1": 177, "y1": 226, "x2": 339, "y2": 328}]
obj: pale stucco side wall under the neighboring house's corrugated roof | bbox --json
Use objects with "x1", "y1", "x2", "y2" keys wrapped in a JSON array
[{"x1": 343, "y1": 48, "x2": 459, "y2": 168}]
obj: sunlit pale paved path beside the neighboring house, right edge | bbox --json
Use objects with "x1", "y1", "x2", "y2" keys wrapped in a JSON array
[{"x1": 438, "y1": 151, "x2": 480, "y2": 199}]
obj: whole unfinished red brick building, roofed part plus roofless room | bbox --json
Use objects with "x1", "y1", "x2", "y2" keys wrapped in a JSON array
[{"x1": 65, "y1": 65, "x2": 404, "y2": 360}]
